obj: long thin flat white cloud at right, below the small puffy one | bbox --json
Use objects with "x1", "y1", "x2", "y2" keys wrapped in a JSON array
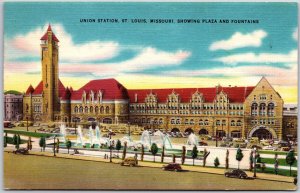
[{"x1": 214, "y1": 50, "x2": 298, "y2": 65}]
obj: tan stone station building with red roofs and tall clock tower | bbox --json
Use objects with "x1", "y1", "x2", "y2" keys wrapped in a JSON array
[{"x1": 23, "y1": 26, "x2": 296, "y2": 139}]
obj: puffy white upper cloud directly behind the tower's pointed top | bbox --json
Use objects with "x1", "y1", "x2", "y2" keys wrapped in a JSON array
[{"x1": 5, "y1": 24, "x2": 120, "y2": 62}]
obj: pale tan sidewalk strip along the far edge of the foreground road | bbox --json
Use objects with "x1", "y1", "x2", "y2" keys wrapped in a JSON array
[{"x1": 4, "y1": 150, "x2": 294, "y2": 183}]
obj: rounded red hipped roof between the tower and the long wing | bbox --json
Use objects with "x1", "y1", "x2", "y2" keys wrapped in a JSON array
[{"x1": 71, "y1": 78, "x2": 128, "y2": 100}]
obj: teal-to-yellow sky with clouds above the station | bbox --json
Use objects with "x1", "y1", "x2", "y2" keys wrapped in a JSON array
[{"x1": 4, "y1": 2, "x2": 298, "y2": 104}]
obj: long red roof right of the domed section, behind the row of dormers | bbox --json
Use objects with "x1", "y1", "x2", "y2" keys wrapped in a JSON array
[{"x1": 128, "y1": 86, "x2": 254, "y2": 103}]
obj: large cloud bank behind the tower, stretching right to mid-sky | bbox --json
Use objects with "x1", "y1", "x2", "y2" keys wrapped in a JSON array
[{"x1": 4, "y1": 24, "x2": 191, "y2": 76}]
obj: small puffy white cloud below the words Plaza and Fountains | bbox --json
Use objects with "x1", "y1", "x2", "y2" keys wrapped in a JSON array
[{"x1": 209, "y1": 30, "x2": 267, "y2": 51}]
